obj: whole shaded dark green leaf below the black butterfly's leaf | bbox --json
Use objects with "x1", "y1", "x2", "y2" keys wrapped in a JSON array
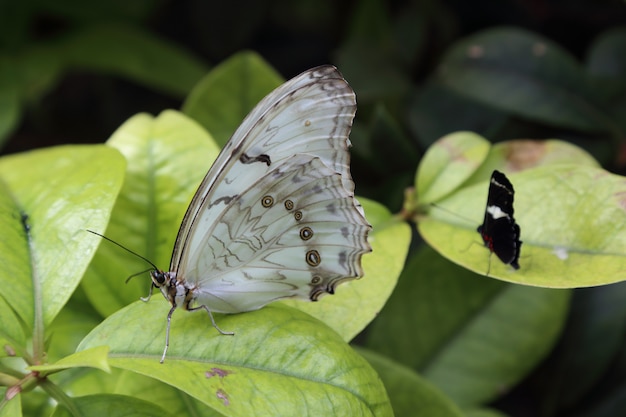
[{"x1": 367, "y1": 247, "x2": 570, "y2": 407}]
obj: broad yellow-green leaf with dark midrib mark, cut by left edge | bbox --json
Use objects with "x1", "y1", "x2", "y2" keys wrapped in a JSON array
[{"x1": 0, "y1": 145, "x2": 124, "y2": 331}]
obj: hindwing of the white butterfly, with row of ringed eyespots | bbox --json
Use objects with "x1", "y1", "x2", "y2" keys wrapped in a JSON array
[{"x1": 185, "y1": 154, "x2": 370, "y2": 313}]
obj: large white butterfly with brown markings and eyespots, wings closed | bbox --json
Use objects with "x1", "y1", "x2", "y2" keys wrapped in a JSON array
[{"x1": 142, "y1": 66, "x2": 371, "y2": 362}]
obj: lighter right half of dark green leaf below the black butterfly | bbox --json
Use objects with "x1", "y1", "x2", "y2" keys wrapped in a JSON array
[{"x1": 423, "y1": 285, "x2": 569, "y2": 405}]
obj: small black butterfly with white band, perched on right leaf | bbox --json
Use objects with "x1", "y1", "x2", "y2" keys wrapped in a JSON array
[{"x1": 477, "y1": 171, "x2": 522, "y2": 269}]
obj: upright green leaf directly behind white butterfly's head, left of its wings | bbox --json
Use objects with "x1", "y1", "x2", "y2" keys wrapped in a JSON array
[{"x1": 83, "y1": 111, "x2": 219, "y2": 316}]
